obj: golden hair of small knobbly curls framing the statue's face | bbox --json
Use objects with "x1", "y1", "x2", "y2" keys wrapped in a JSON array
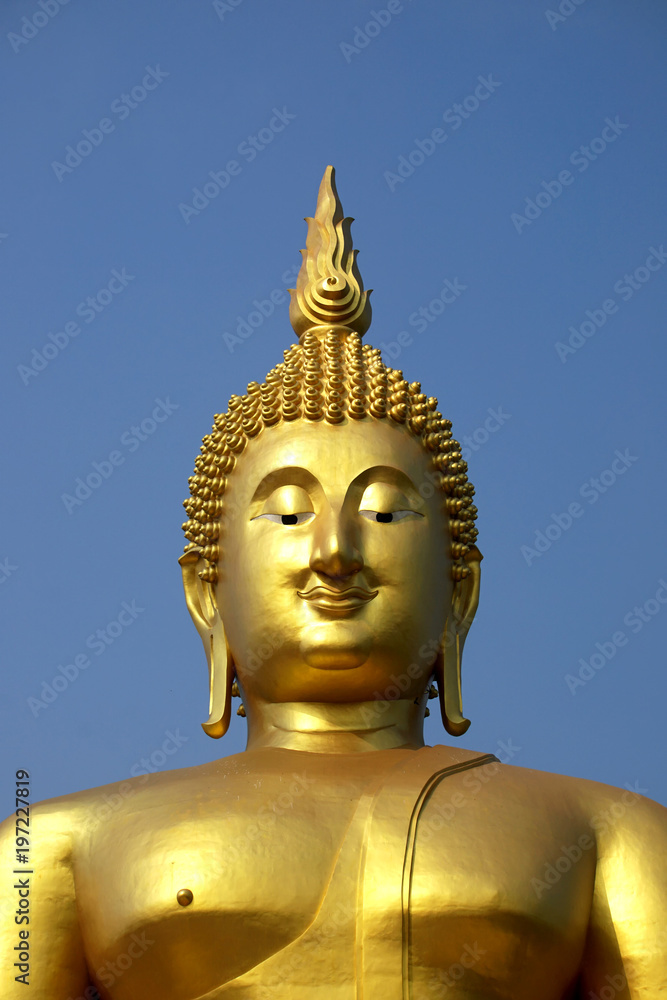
[{"x1": 183, "y1": 327, "x2": 477, "y2": 583}]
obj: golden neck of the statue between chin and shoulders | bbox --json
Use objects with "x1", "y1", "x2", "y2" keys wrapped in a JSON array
[{"x1": 246, "y1": 699, "x2": 424, "y2": 753}]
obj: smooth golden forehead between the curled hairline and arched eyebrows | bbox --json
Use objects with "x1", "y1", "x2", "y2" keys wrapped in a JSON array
[{"x1": 229, "y1": 417, "x2": 430, "y2": 500}]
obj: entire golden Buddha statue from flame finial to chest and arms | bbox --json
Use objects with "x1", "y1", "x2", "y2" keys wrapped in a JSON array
[{"x1": 1, "y1": 167, "x2": 667, "y2": 1000}]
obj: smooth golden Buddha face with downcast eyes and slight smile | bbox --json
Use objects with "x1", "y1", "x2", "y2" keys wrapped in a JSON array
[{"x1": 216, "y1": 419, "x2": 453, "y2": 702}]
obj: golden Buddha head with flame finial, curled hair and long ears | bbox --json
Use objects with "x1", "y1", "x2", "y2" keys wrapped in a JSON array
[{"x1": 180, "y1": 167, "x2": 481, "y2": 737}]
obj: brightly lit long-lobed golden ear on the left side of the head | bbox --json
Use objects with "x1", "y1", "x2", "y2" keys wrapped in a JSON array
[{"x1": 178, "y1": 548, "x2": 234, "y2": 739}]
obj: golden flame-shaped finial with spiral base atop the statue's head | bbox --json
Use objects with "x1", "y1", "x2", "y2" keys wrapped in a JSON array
[{"x1": 290, "y1": 166, "x2": 371, "y2": 338}]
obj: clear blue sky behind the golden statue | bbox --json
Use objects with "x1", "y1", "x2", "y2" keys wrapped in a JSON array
[{"x1": 0, "y1": 0, "x2": 667, "y2": 814}]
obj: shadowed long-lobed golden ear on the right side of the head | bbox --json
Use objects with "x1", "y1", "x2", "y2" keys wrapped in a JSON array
[{"x1": 436, "y1": 545, "x2": 483, "y2": 736}]
